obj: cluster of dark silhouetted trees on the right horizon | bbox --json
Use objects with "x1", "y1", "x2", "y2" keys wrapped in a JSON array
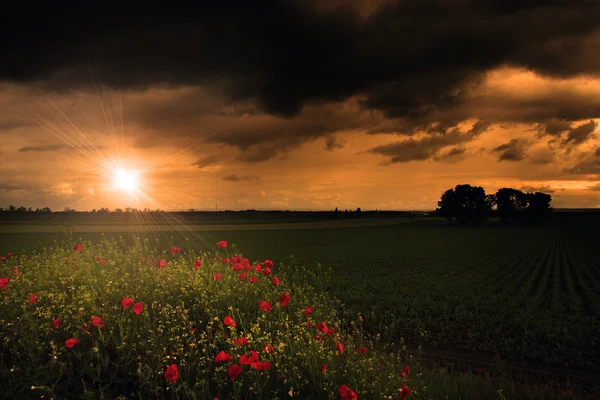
[{"x1": 436, "y1": 184, "x2": 552, "y2": 224}]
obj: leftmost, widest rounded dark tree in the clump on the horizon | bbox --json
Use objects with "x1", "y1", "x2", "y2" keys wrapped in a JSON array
[{"x1": 436, "y1": 184, "x2": 491, "y2": 224}]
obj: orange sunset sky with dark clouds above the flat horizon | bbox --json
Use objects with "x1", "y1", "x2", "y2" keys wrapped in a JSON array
[{"x1": 0, "y1": 0, "x2": 600, "y2": 210}]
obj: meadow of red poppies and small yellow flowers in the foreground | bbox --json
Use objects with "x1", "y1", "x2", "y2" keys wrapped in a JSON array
[{"x1": 0, "y1": 239, "x2": 414, "y2": 400}]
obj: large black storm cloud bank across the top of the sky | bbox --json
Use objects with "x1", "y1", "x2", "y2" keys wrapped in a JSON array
[{"x1": 0, "y1": 0, "x2": 600, "y2": 120}]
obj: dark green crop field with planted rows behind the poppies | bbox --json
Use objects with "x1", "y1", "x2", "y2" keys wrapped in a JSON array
[{"x1": 0, "y1": 212, "x2": 600, "y2": 376}]
